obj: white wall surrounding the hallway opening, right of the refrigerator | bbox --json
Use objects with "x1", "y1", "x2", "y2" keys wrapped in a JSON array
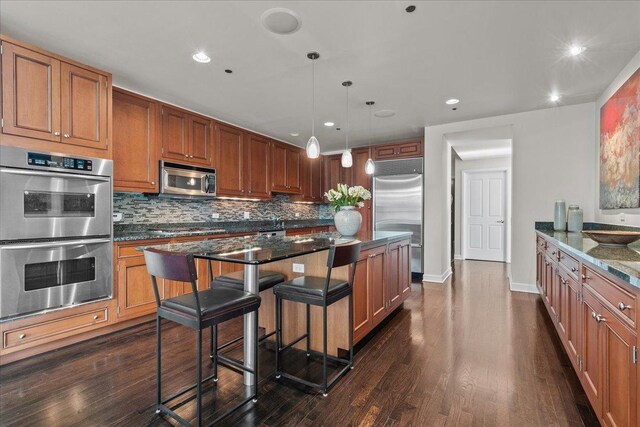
[{"x1": 424, "y1": 102, "x2": 596, "y2": 292}]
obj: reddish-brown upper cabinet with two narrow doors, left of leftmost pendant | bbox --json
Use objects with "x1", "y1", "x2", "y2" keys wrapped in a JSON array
[{"x1": 271, "y1": 141, "x2": 302, "y2": 194}]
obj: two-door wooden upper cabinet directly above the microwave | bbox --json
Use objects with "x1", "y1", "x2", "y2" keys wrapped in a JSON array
[{"x1": 160, "y1": 105, "x2": 213, "y2": 166}]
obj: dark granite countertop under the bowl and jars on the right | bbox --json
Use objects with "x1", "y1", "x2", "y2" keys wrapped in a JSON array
[{"x1": 536, "y1": 223, "x2": 640, "y2": 288}]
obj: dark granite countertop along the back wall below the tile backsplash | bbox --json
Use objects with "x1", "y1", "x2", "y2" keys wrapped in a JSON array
[{"x1": 113, "y1": 219, "x2": 333, "y2": 242}]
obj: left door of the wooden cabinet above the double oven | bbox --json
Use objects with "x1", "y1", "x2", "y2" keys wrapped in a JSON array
[{"x1": 2, "y1": 42, "x2": 61, "y2": 142}]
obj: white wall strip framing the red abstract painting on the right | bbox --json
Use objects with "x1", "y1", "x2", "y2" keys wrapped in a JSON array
[{"x1": 594, "y1": 51, "x2": 640, "y2": 226}]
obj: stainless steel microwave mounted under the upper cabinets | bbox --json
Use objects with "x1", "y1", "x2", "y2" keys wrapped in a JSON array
[{"x1": 160, "y1": 161, "x2": 216, "y2": 197}]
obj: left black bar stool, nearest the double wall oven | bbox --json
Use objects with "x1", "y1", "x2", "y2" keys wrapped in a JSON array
[{"x1": 144, "y1": 249, "x2": 261, "y2": 426}]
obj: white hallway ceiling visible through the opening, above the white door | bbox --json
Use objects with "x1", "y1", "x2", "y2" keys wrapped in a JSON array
[{"x1": 445, "y1": 126, "x2": 513, "y2": 161}]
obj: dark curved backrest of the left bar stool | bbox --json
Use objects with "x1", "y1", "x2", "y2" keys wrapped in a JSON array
[{"x1": 144, "y1": 249, "x2": 200, "y2": 313}]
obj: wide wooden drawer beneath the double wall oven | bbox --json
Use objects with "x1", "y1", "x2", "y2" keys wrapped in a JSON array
[{"x1": 2, "y1": 307, "x2": 109, "y2": 348}]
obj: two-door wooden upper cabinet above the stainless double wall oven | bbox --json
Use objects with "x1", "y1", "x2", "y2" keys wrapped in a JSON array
[{"x1": 2, "y1": 40, "x2": 111, "y2": 157}]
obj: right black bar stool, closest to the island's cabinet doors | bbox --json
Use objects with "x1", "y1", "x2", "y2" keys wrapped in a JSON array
[{"x1": 273, "y1": 241, "x2": 361, "y2": 397}]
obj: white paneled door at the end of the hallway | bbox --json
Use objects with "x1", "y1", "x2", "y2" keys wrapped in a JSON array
[{"x1": 462, "y1": 171, "x2": 506, "y2": 262}]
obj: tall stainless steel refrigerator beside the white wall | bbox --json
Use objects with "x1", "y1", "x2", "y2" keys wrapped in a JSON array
[{"x1": 373, "y1": 159, "x2": 423, "y2": 273}]
